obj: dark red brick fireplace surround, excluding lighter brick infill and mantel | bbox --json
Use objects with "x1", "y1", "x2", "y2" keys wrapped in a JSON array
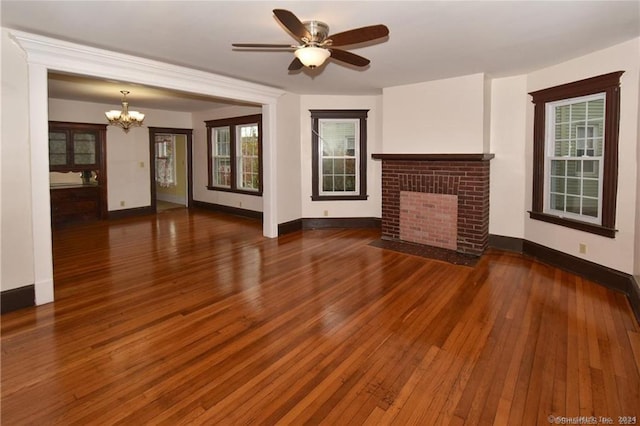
[{"x1": 382, "y1": 159, "x2": 489, "y2": 256}]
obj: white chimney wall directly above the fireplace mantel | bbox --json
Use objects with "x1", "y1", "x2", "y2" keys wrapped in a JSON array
[{"x1": 382, "y1": 74, "x2": 490, "y2": 154}]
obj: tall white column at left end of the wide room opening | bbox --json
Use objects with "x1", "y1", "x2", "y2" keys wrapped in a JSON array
[{"x1": 29, "y1": 64, "x2": 53, "y2": 305}]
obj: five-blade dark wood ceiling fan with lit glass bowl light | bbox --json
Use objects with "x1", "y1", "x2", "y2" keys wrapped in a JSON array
[{"x1": 232, "y1": 9, "x2": 389, "y2": 71}]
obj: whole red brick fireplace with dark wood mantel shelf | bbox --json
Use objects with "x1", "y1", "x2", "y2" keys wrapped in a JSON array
[{"x1": 372, "y1": 154, "x2": 494, "y2": 256}]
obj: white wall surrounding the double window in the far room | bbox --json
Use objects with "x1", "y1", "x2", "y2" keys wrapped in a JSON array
[{"x1": 192, "y1": 105, "x2": 263, "y2": 212}]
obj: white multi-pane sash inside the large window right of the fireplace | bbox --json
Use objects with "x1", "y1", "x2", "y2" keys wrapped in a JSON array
[{"x1": 544, "y1": 92, "x2": 606, "y2": 224}]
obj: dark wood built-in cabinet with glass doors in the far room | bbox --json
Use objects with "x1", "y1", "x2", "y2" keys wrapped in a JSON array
[{"x1": 49, "y1": 121, "x2": 107, "y2": 228}]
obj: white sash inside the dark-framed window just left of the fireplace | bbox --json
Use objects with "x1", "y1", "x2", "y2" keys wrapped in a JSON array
[{"x1": 318, "y1": 118, "x2": 360, "y2": 196}]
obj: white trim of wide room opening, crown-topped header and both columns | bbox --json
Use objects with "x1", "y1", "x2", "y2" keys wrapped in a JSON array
[{"x1": 9, "y1": 30, "x2": 285, "y2": 305}]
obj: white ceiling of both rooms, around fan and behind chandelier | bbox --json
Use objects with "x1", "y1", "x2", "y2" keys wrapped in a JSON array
[{"x1": 0, "y1": 0, "x2": 640, "y2": 111}]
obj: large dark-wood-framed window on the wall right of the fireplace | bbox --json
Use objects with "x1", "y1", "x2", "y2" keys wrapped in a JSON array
[{"x1": 530, "y1": 72, "x2": 622, "y2": 238}]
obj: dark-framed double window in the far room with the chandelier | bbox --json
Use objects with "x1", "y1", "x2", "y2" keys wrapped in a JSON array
[{"x1": 205, "y1": 114, "x2": 262, "y2": 195}]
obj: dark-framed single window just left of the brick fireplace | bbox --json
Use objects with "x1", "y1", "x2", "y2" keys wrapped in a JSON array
[{"x1": 310, "y1": 110, "x2": 368, "y2": 201}]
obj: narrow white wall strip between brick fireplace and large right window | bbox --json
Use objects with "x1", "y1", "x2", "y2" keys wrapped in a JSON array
[{"x1": 489, "y1": 76, "x2": 529, "y2": 238}]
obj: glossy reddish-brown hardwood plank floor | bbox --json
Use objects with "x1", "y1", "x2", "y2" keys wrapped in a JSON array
[{"x1": 1, "y1": 209, "x2": 640, "y2": 425}]
